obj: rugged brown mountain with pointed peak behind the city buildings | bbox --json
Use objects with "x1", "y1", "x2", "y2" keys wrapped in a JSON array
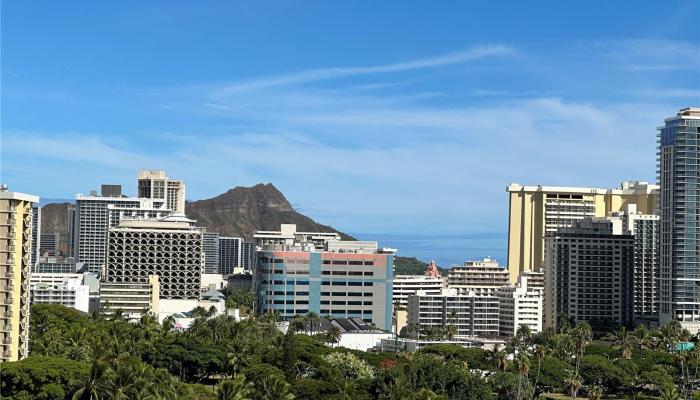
[{"x1": 185, "y1": 183, "x2": 355, "y2": 240}]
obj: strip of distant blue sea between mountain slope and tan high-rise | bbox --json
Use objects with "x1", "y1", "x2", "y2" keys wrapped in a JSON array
[{"x1": 349, "y1": 233, "x2": 507, "y2": 267}]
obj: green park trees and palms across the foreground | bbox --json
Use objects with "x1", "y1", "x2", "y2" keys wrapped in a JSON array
[{"x1": 0, "y1": 299, "x2": 700, "y2": 400}]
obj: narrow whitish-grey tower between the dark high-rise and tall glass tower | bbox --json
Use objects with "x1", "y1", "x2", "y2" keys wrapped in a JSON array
[{"x1": 611, "y1": 204, "x2": 661, "y2": 328}]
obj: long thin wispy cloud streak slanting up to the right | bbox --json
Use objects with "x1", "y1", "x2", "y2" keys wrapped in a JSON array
[{"x1": 215, "y1": 45, "x2": 515, "y2": 95}]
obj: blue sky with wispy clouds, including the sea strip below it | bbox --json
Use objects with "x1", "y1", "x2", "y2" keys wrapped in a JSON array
[{"x1": 0, "y1": 1, "x2": 700, "y2": 265}]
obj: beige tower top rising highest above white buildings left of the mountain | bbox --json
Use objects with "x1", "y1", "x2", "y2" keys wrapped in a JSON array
[{"x1": 138, "y1": 170, "x2": 185, "y2": 214}]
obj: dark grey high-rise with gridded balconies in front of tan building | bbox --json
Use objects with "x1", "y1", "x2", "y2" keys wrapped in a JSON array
[{"x1": 544, "y1": 218, "x2": 634, "y2": 329}]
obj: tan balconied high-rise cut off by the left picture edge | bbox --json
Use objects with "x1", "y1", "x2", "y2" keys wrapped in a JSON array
[{"x1": 0, "y1": 186, "x2": 39, "y2": 362}]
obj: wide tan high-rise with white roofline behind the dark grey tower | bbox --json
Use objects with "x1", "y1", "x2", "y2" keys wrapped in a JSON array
[{"x1": 506, "y1": 182, "x2": 659, "y2": 283}]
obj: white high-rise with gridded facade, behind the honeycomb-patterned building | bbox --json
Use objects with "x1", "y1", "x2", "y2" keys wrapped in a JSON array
[{"x1": 71, "y1": 185, "x2": 170, "y2": 274}]
